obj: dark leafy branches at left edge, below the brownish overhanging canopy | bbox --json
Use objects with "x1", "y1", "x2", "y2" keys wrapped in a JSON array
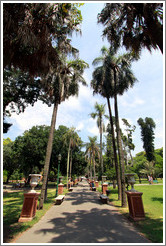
[{"x1": 3, "y1": 68, "x2": 42, "y2": 133}]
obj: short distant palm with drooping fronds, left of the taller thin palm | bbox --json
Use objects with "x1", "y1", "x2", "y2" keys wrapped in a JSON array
[{"x1": 85, "y1": 136, "x2": 100, "y2": 178}]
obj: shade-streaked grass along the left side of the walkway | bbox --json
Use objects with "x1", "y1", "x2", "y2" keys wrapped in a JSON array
[{"x1": 3, "y1": 188, "x2": 68, "y2": 243}]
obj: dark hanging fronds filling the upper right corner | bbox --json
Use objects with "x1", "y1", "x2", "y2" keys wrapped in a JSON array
[{"x1": 98, "y1": 3, "x2": 163, "y2": 54}]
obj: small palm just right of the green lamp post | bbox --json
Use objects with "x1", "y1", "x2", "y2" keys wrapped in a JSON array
[{"x1": 63, "y1": 127, "x2": 81, "y2": 188}]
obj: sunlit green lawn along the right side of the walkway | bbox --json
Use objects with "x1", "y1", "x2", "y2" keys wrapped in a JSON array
[{"x1": 105, "y1": 185, "x2": 163, "y2": 243}]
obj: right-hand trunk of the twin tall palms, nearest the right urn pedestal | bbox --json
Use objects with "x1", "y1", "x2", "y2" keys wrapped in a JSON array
[{"x1": 114, "y1": 95, "x2": 127, "y2": 207}]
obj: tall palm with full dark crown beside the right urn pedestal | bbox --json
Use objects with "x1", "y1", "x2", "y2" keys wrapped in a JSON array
[{"x1": 92, "y1": 47, "x2": 136, "y2": 207}]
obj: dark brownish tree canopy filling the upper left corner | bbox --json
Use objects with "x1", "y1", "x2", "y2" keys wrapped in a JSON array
[{"x1": 3, "y1": 3, "x2": 82, "y2": 76}]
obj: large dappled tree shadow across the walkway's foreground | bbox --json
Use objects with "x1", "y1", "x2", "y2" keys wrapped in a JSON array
[{"x1": 35, "y1": 208, "x2": 149, "y2": 243}]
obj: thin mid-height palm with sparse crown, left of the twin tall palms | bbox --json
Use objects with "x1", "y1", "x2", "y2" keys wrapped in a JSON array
[{"x1": 90, "y1": 102, "x2": 105, "y2": 174}]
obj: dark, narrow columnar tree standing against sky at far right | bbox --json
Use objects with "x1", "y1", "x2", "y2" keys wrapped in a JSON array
[{"x1": 137, "y1": 117, "x2": 156, "y2": 162}]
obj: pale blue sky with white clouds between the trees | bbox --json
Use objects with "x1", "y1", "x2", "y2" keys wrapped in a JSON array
[{"x1": 3, "y1": 2, "x2": 165, "y2": 155}]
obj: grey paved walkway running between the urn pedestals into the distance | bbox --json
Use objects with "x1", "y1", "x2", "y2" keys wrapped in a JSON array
[{"x1": 13, "y1": 181, "x2": 150, "y2": 244}]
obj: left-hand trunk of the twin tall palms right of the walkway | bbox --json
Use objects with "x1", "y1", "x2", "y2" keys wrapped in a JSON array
[{"x1": 107, "y1": 97, "x2": 121, "y2": 200}]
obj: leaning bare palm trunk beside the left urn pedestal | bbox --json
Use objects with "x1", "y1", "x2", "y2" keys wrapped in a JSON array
[{"x1": 39, "y1": 103, "x2": 58, "y2": 209}]
